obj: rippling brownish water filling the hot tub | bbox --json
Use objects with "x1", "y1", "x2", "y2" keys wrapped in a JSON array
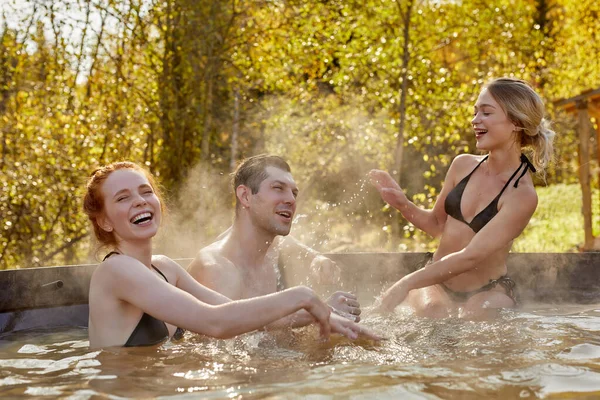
[{"x1": 0, "y1": 305, "x2": 600, "y2": 399}]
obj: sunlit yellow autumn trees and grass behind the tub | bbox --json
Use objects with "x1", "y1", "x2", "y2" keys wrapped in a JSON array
[{"x1": 0, "y1": 0, "x2": 600, "y2": 269}]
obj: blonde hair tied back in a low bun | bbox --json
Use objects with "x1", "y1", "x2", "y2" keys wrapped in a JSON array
[{"x1": 485, "y1": 78, "x2": 556, "y2": 169}]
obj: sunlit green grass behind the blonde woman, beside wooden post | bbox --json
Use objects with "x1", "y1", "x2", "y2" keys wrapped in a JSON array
[{"x1": 512, "y1": 184, "x2": 600, "y2": 253}]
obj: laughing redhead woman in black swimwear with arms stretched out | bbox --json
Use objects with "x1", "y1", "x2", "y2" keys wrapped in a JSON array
[{"x1": 84, "y1": 162, "x2": 376, "y2": 348}]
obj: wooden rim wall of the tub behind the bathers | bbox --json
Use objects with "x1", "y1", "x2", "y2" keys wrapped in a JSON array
[{"x1": 0, "y1": 253, "x2": 600, "y2": 333}]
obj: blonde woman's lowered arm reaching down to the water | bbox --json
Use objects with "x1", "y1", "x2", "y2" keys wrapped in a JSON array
[{"x1": 379, "y1": 186, "x2": 537, "y2": 310}]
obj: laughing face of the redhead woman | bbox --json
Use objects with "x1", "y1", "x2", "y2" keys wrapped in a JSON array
[{"x1": 97, "y1": 169, "x2": 161, "y2": 242}]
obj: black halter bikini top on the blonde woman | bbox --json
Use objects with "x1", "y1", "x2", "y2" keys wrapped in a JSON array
[{"x1": 444, "y1": 154, "x2": 535, "y2": 233}]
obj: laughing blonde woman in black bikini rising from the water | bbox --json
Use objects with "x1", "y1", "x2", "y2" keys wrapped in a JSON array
[{"x1": 370, "y1": 78, "x2": 554, "y2": 319}]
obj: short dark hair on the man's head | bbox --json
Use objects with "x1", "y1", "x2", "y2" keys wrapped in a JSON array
[{"x1": 232, "y1": 154, "x2": 292, "y2": 198}]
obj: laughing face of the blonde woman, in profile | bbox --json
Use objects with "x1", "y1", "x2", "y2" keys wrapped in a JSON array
[{"x1": 471, "y1": 89, "x2": 516, "y2": 151}]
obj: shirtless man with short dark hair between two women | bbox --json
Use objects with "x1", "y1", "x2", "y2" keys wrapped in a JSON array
[{"x1": 188, "y1": 155, "x2": 361, "y2": 326}]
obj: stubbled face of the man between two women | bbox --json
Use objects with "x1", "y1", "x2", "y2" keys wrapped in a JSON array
[{"x1": 248, "y1": 167, "x2": 298, "y2": 236}]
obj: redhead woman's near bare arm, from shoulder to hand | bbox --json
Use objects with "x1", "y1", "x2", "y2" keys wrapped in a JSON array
[{"x1": 101, "y1": 256, "x2": 330, "y2": 339}]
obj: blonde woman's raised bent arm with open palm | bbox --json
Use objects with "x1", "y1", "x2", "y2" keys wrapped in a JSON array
[{"x1": 369, "y1": 155, "x2": 472, "y2": 237}]
